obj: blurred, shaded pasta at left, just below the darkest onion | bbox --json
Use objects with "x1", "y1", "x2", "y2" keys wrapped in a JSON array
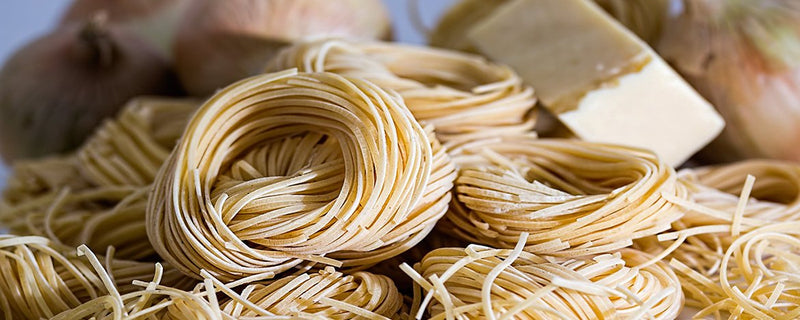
[{"x1": 0, "y1": 98, "x2": 197, "y2": 260}]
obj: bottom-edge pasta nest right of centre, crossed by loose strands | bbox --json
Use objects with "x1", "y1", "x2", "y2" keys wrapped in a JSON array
[{"x1": 403, "y1": 239, "x2": 683, "y2": 319}]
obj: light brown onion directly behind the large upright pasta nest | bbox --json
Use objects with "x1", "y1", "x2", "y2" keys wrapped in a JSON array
[{"x1": 173, "y1": 0, "x2": 391, "y2": 96}]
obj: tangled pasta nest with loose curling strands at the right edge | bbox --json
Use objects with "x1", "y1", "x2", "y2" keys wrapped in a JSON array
[{"x1": 636, "y1": 160, "x2": 800, "y2": 319}]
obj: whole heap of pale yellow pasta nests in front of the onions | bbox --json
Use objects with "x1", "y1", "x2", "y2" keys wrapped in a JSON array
[{"x1": 0, "y1": 39, "x2": 800, "y2": 319}]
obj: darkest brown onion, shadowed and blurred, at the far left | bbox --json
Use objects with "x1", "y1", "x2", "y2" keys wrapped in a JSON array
[{"x1": 0, "y1": 15, "x2": 177, "y2": 162}]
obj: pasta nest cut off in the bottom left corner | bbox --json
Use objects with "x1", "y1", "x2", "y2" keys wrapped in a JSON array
[{"x1": 0, "y1": 235, "x2": 190, "y2": 319}]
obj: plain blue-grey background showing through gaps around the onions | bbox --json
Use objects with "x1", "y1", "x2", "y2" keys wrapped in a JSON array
[{"x1": 0, "y1": 0, "x2": 455, "y2": 188}]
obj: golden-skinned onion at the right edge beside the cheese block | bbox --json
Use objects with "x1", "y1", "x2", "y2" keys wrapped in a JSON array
[{"x1": 658, "y1": 0, "x2": 800, "y2": 162}]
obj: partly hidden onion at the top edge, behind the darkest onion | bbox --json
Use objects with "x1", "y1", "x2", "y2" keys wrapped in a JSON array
[{"x1": 61, "y1": 0, "x2": 190, "y2": 56}]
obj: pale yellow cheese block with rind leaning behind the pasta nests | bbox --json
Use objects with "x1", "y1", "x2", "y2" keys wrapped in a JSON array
[{"x1": 468, "y1": 0, "x2": 724, "y2": 166}]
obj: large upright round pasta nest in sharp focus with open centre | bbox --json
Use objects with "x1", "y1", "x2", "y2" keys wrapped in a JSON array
[{"x1": 147, "y1": 70, "x2": 454, "y2": 281}]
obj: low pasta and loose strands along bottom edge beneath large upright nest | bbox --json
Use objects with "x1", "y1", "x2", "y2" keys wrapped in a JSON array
[{"x1": 53, "y1": 265, "x2": 402, "y2": 320}]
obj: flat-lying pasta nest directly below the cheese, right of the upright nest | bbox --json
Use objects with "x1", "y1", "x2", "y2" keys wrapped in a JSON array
[{"x1": 446, "y1": 136, "x2": 686, "y2": 257}]
